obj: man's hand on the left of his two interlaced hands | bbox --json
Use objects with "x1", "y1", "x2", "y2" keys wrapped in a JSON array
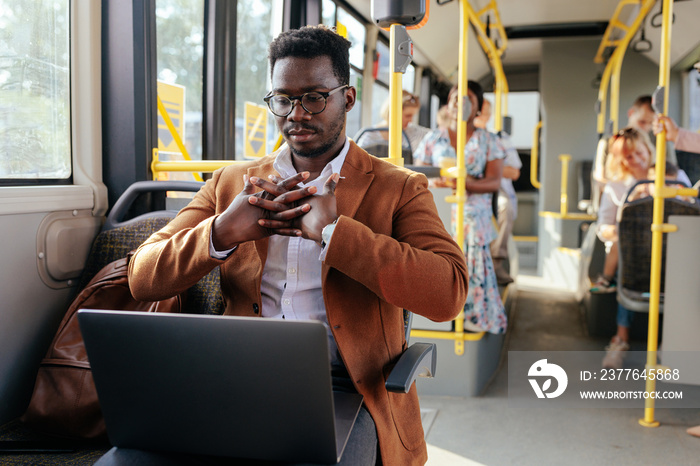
[{"x1": 212, "y1": 172, "x2": 316, "y2": 251}]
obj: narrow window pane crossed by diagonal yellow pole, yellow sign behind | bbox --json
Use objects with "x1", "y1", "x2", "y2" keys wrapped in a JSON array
[{"x1": 156, "y1": 0, "x2": 204, "y2": 160}]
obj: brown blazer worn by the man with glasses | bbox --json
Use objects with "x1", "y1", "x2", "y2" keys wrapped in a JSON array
[{"x1": 129, "y1": 142, "x2": 468, "y2": 466}]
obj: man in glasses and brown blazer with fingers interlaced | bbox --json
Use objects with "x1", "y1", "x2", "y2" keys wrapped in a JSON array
[{"x1": 129, "y1": 26, "x2": 468, "y2": 466}]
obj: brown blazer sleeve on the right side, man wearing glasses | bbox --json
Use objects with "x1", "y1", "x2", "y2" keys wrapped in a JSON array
[{"x1": 324, "y1": 173, "x2": 468, "y2": 321}]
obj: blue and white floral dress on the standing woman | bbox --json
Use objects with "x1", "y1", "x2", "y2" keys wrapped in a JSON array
[{"x1": 413, "y1": 128, "x2": 507, "y2": 333}]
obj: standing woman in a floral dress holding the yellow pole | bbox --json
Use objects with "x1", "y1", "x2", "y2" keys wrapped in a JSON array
[{"x1": 413, "y1": 81, "x2": 507, "y2": 333}]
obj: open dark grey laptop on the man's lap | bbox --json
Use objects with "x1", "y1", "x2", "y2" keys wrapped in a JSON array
[{"x1": 78, "y1": 310, "x2": 362, "y2": 464}]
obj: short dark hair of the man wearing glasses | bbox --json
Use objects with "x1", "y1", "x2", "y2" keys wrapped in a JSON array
[{"x1": 268, "y1": 25, "x2": 351, "y2": 85}]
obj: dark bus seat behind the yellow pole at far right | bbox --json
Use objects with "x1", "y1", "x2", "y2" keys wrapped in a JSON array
[{"x1": 617, "y1": 180, "x2": 700, "y2": 312}]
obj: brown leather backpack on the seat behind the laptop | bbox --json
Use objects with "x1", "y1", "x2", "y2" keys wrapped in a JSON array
[{"x1": 22, "y1": 257, "x2": 184, "y2": 439}]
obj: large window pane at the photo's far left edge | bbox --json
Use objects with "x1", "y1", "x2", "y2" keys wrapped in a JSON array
[{"x1": 0, "y1": 0, "x2": 71, "y2": 180}]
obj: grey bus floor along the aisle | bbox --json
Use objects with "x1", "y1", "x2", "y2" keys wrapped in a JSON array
[{"x1": 419, "y1": 276, "x2": 700, "y2": 466}]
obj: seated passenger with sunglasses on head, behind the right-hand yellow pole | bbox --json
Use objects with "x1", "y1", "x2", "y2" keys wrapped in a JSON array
[{"x1": 591, "y1": 127, "x2": 654, "y2": 369}]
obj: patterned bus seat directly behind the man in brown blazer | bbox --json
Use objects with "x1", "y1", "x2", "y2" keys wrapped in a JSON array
[{"x1": 78, "y1": 181, "x2": 224, "y2": 314}]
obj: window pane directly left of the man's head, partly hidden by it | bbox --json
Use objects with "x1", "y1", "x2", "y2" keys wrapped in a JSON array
[{"x1": 235, "y1": 0, "x2": 283, "y2": 159}]
